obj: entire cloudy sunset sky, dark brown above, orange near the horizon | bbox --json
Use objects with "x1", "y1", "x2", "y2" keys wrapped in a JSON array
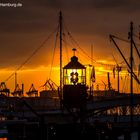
[{"x1": 0, "y1": 0, "x2": 140, "y2": 92}]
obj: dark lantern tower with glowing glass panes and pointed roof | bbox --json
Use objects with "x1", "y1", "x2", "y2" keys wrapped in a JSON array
[{"x1": 63, "y1": 49, "x2": 87, "y2": 108}]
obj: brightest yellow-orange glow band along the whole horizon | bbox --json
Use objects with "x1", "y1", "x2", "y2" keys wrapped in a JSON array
[{"x1": 0, "y1": 54, "x2": 140, "y2": 92}]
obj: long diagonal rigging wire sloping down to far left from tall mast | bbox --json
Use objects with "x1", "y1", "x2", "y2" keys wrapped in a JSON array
[{"x1": 5, "y1": 29, "x2": 56, "y2": 82}]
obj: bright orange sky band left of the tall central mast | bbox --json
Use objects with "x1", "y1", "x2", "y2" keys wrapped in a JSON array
[{"x1": 0, "y1": 66, "x2": 59, "y2": 92}]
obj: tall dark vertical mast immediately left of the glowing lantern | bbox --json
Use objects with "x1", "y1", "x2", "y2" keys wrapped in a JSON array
[{"x1": 59, "y1": 11, "x2": 63, "y2": 96}]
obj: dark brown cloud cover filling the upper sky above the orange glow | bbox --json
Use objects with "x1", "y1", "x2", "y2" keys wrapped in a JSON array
[{"x1": 0, "y1": 0, "x2": 140, "y2": 67}]
